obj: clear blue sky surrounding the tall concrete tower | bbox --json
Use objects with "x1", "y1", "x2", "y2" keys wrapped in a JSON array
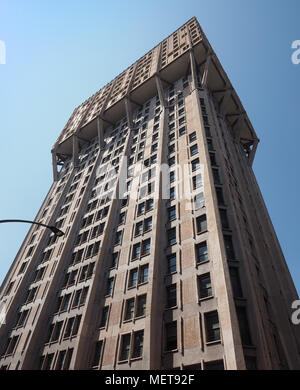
[{"x1": 0, "y1": 0, "x2": 300, "y2": 291}]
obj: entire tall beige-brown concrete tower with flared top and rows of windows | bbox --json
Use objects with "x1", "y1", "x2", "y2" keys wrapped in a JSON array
[{"x1": 0, "y1": 18, "x2": 300, "y2": 370}]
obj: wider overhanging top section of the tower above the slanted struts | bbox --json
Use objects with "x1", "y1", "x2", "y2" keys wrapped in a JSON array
[{"x1": 53, "y1": 18, "x2": 258, "y2": 162}]
